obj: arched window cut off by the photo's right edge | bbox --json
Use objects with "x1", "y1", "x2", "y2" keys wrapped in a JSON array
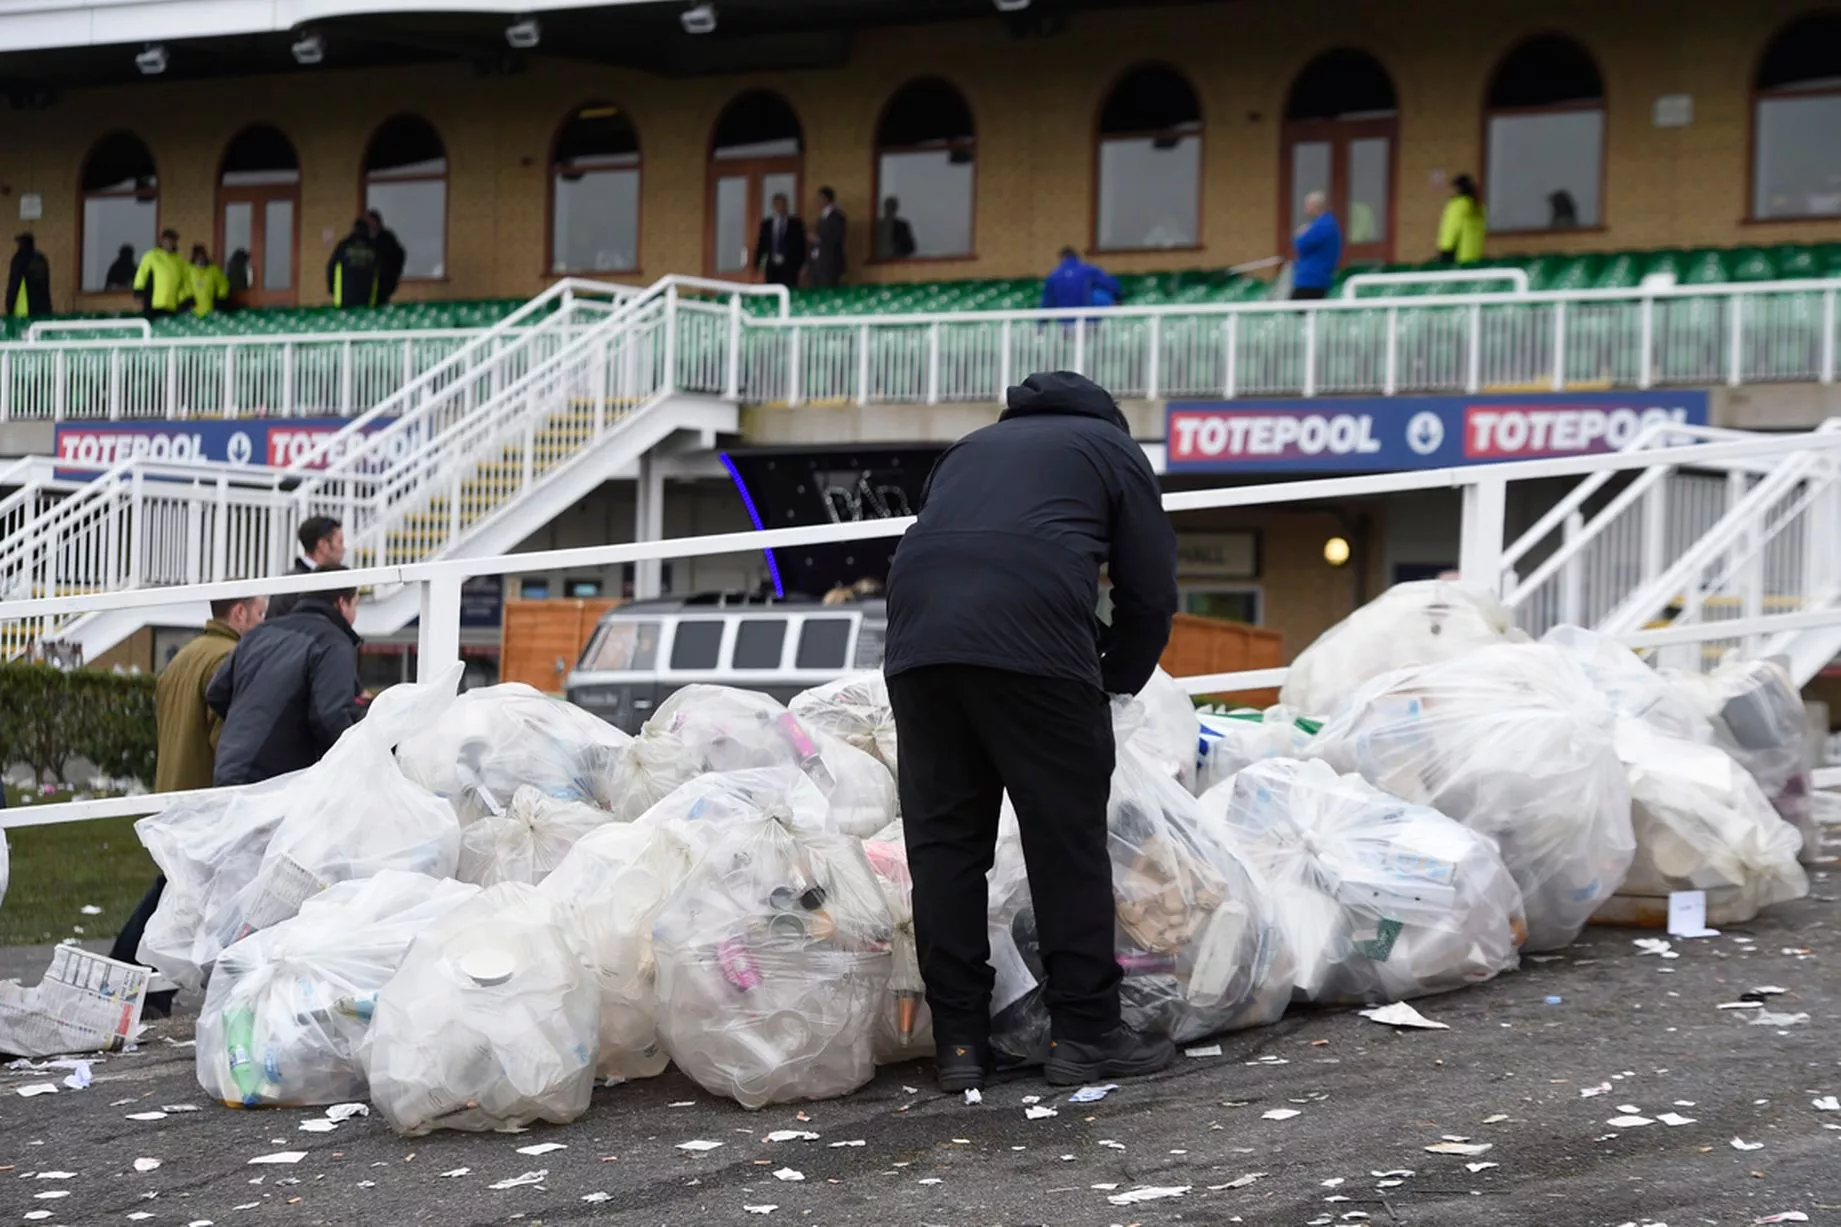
[{"x1": 1751, "y1": 13, "x2": 1841, "y2": 219}]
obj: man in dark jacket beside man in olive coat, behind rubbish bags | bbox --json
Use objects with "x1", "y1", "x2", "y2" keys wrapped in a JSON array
[{"x1": 204, "y1": 567, "x2": 363, "y2": 789}]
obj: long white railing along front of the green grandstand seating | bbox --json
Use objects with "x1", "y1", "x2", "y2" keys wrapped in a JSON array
[{"x1": 0, "y1": 269, "x2": 1841, "y2": 420}]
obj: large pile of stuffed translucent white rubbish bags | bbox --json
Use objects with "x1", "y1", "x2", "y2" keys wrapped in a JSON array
[{"x1": 82, "y1": 582, "x2": 1808, "y2": 1135}]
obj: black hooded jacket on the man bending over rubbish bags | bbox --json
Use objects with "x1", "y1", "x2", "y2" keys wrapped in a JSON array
[{"x1": 884, "y1": 370, "x2": 1176, "y2": 695}]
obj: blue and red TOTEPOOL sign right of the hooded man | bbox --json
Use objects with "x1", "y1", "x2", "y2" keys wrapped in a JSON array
[{"x1": 1165, "y1": 392, "x2": 1707, "y2": 473}]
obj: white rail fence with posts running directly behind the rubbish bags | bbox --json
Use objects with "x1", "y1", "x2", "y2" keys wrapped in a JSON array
[{"x1": 0, "y1": 425, "x2": 1841, "y2": 825}]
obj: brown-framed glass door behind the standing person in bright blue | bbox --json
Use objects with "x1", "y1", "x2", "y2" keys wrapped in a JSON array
[{"x1": 1279, "y1": 118, "x2": 1394, "y2": 263}]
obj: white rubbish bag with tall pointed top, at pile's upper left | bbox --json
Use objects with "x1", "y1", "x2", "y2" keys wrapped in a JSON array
[{"x1": 203, "y1": 665, "x2": 460, "y2": 958}]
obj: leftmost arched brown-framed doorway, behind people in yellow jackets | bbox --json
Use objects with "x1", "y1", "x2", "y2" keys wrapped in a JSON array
[{"x1": 215, "y1": 123, "x2": 300, "y2": 306}]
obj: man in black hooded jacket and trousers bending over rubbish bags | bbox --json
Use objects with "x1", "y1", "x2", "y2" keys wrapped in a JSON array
[{"x1": 884, "y1": 372, "x2": 1176, "y2": 1091}]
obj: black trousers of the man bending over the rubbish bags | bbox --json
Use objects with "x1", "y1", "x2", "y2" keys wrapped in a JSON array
[{"x1": 889, "y1": 665, "x2": 1119, "y2": 1043}]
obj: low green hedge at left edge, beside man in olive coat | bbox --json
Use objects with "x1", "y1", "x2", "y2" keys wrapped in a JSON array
[{"x1": 0, "y1": 665, "x2": 158, "y2": 785}]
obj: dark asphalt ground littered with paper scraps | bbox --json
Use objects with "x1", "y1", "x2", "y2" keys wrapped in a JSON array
[{"x1": 0, "y1": 873, "x2": 1841, "y2": 1227}]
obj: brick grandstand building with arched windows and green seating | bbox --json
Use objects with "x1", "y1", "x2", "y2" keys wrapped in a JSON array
[{"x1": 0, "y1": 0, "x2": 1841, "y2": 677}]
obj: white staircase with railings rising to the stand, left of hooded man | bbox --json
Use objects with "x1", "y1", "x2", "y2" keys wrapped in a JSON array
[{"x1": 0, "y1": 278, "x2": 786, "y2": 660}]
